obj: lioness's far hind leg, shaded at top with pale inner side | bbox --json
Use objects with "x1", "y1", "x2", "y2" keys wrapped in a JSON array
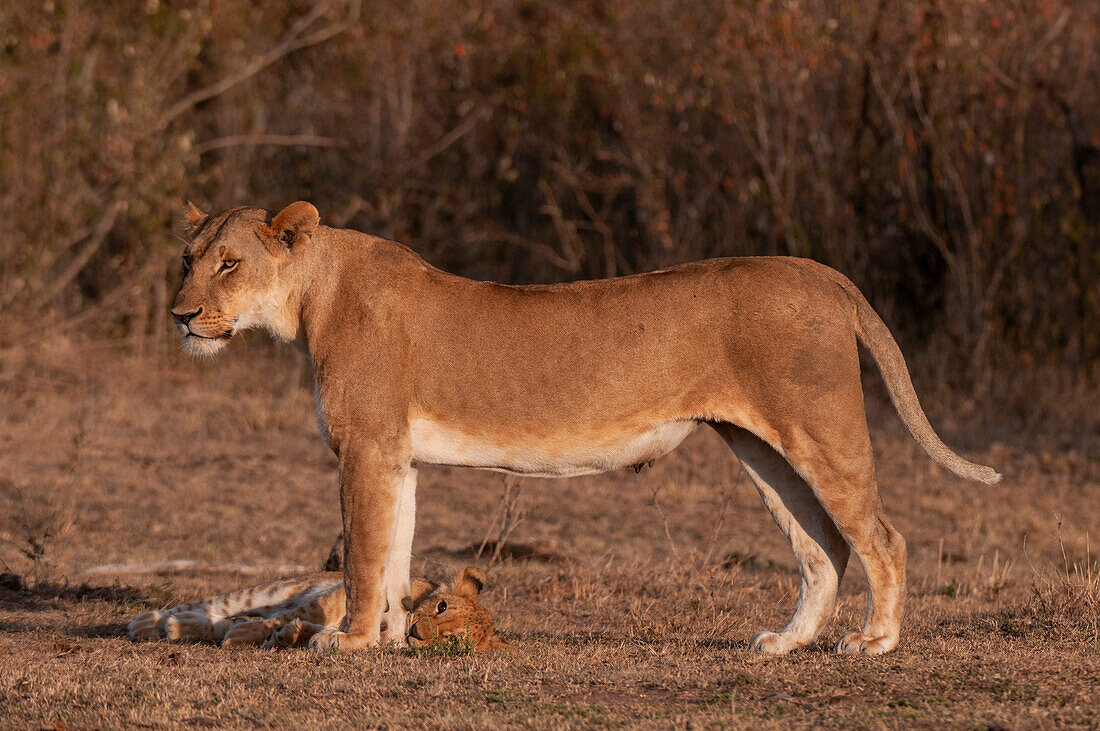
[{"x1": 715, "y1": 424, "x2": 849, "y2": 654}]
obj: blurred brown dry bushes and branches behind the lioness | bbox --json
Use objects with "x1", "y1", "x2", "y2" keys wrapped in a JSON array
[{"x1": 0, "y1": 0, "x2": 1100, "y2": 387}]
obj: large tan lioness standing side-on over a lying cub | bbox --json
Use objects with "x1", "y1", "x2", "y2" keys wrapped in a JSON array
[{"x1": 172, "y1": 201, "x2": 1000, "y2": 654}]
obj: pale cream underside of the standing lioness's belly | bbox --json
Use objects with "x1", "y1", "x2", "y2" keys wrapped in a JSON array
[{"x1": 410, "y1": 418, "x2": 699, "y2": 477}]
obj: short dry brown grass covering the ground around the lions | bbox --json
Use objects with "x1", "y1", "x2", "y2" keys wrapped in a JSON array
[{"x1": 0, "y1": 337, "x2": 1100, "y2": 728}]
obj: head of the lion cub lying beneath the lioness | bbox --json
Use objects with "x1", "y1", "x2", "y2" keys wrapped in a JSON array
[{"x1": 405, "y1": 566, "x2": 510, "y2": 652}]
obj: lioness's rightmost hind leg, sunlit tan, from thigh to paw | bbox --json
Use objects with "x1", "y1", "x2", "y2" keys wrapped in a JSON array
[{"x1": 783, "y1": 422, "x2": 905, "y2": 655}]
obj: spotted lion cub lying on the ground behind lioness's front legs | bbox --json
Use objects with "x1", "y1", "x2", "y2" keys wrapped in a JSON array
[{"x1": 128, "y1": 566, "x2": 509, "y2": 651}]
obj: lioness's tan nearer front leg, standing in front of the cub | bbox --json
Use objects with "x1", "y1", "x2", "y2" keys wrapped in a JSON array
[{"x1": 309, "y1": 440, "x2": 410, "y2": 652}]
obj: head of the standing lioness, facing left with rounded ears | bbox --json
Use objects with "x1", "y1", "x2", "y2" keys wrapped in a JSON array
[{"x1": 172, "y1": 201, "x2": 320, "y2": 355}]
